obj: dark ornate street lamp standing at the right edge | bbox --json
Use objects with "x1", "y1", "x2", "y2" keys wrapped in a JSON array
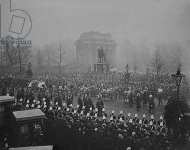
[{"x1": 171, "y1": 67, "x2": 185, "y2": 101}]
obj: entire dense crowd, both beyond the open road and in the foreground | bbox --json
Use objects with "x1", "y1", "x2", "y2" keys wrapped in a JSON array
[{"x1": 0, "y1": 73, "x2": 186, "y2": 150}]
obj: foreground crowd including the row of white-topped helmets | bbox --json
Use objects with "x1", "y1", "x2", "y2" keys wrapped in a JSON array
[{"x1": 19, "y1": 98, "x2": 171, "y2": 150}]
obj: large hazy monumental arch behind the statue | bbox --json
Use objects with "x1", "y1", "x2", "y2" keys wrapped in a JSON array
[{"x1": 75, "y1": 31, "x2": 116, "y2": 71}]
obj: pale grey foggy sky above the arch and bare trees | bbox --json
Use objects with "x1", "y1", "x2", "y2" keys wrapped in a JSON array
[{"x1": 12, "y1": 0, "x2": 190, "y2": 72}]
